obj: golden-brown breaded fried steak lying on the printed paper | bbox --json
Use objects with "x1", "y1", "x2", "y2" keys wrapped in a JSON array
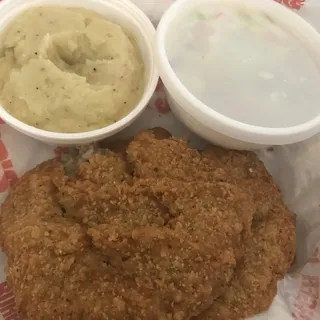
[{"x1": 0, "y1": 130, "x2": 295, "y2": 320}]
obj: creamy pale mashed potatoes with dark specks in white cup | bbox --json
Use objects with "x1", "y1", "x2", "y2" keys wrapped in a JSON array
[{"x1": 0, "y1": 7, "x2": 144, "y2": 133}]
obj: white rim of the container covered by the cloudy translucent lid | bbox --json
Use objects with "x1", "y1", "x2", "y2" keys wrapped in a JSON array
[{"x1": 156, "y1": 0, "x2": 320, "y2": 144}]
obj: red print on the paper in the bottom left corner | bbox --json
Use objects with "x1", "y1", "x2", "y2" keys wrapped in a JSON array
[{"x1": 0, "y1": 281, "x2": 24, "y2": 320}]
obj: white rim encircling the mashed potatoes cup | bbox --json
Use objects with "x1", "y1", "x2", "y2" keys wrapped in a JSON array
[{"x1": 0, "y1": 0, "x2": 159, "y2": 142}]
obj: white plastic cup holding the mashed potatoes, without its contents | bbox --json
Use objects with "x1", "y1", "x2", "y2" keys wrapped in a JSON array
[{"x1": 0, "y1": 0, "x2": 159, "y2": 145}]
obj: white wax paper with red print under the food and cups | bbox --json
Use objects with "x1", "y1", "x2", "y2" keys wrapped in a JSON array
[{"x1": 0, "y1": 0, "x2": 320, "y2": 320}]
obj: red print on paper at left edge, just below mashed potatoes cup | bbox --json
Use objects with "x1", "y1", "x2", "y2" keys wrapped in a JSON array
[{"x1": 0, "y1": 134, "x2": 18, "y2": 193}]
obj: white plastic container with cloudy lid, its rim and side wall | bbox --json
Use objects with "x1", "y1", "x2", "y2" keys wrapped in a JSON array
[{"x1": 156, "y1": 0, "x2": 320, "y2": 149}]
